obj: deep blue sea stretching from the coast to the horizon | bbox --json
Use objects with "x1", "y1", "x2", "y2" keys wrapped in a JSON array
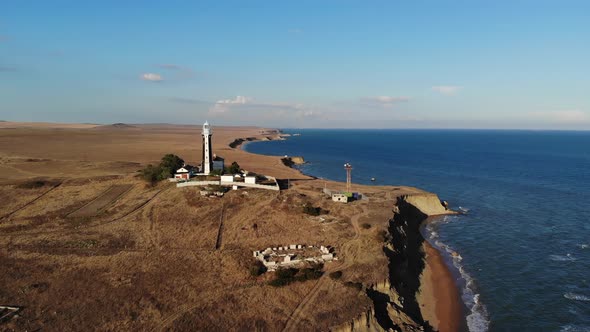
[{"x1": 245, "y1": 130, "x2": 590, "y2": 331}]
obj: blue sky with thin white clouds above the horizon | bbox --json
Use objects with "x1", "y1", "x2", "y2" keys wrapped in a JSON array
[{"x1": 0, "y1": 0, "x2": 590, "y2": 130}]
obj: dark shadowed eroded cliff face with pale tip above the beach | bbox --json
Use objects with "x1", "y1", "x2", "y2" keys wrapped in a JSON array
[{"x1": 333, "y1": 193, "x2": 453, "y2": 332}]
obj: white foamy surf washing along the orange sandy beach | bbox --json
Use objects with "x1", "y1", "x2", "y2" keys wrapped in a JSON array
[{"x1": 425, "y1": 217, "x2": 490, "y2": 332}]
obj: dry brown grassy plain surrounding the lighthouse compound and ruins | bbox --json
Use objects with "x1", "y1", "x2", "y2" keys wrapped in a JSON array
[{"x1": 0, "y1": 123, "x2": 426, "y2": 331}]
